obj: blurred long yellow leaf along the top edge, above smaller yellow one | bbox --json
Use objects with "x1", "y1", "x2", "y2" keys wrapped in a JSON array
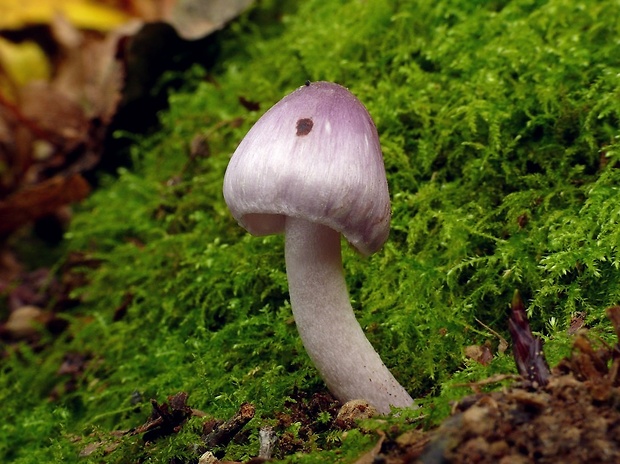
[{"x1": 0, "y1": 0, "x2": 131, "y2": 31}]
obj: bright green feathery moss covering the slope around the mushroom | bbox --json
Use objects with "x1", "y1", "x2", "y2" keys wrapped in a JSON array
[{"x1": 0, "y1": 0, "x2": 620, "y2": 462}]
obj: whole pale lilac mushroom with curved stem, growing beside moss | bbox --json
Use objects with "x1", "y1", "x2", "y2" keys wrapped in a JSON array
[{"x1": 224, "y1": 82, "x2": 413, "y2": 413}]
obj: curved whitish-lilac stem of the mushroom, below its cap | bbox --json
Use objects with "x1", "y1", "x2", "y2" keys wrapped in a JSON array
[{"x1": 285, "y1": 217, "x2": 413, "y2": 414}]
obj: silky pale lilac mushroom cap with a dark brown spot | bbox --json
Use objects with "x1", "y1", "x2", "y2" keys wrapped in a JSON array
[{"x1": 224, "y1": 82, "x2": 390, "y2": 255}]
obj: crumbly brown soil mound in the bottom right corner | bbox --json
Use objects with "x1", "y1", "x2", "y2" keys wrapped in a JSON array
[{"x1": 366, "y1": 314, "x2": 620, "y2": 464}]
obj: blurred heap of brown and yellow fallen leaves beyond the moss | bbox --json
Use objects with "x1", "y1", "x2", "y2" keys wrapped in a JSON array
[{"x1": 0, "y1": 0, "x2": 253, "y2": 238}]
